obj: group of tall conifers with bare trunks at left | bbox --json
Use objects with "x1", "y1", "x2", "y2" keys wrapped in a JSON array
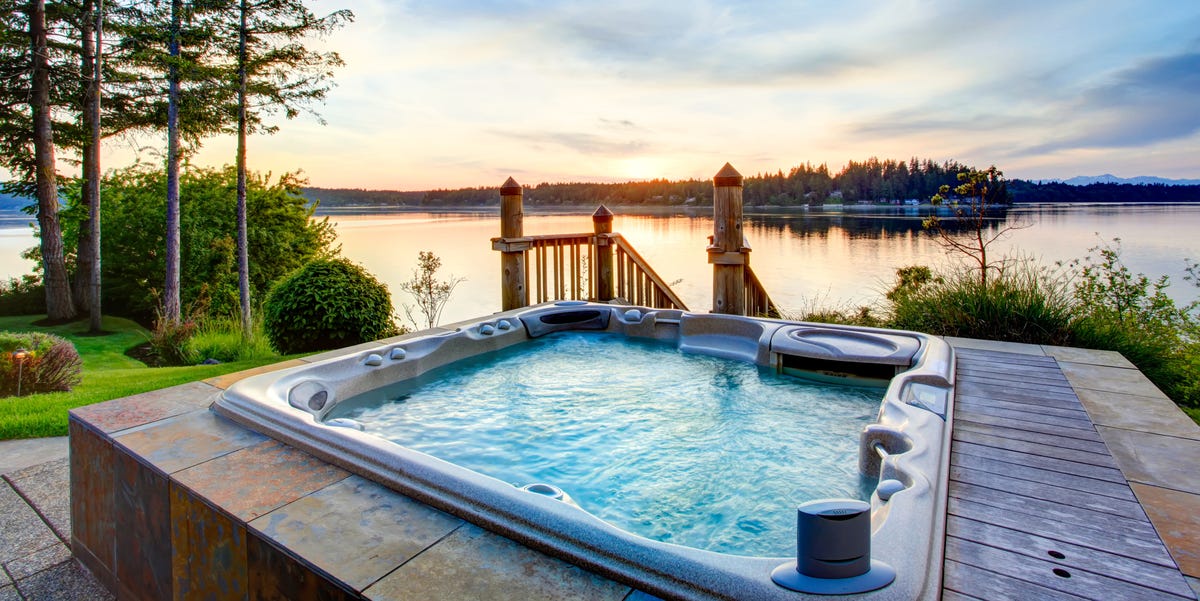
[{"x1": 0, "y1": 0, "x2": 353, "y2": 331}]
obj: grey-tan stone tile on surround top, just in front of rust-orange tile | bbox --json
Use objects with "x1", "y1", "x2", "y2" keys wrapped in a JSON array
[{"x1": 250, "y1": 476, "x2": 462, "y2": 590}]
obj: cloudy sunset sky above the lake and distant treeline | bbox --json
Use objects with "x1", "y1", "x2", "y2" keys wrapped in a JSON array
[{"x1": 104, "y1": 0, "x2": 1200, "y2": 190}]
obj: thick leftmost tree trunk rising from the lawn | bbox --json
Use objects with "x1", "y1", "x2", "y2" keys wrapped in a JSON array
[{"x1": 29, "y1": 0, "x2": 76, "y2": 321}]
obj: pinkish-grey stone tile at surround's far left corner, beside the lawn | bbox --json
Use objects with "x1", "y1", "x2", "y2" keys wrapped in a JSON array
[{"x1": 71, "y1": 381, "x2": 221, "y2": 433}]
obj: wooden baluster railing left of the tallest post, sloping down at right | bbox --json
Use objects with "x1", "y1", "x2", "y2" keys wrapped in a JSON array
[{"x1": 524, "y1": 233, "x2": 688, "y2": 311}]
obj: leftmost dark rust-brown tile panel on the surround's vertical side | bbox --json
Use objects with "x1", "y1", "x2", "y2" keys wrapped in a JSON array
[{"x1": 67, "y1": 417, "x2": 116, "y2": 581}]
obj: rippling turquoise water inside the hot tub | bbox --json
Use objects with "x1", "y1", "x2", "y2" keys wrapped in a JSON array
[{"x1": 330, "y1": 332, "x2": 883, "y2": 557}]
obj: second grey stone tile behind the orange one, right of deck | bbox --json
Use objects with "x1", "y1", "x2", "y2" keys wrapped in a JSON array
[{"x1": 1075, "y1": 389, "x2": 1200, "y2": 440}]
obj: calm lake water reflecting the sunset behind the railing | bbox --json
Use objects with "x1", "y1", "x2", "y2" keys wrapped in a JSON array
[{"x1": 0, "y1": 204, "x2": 1200, "y2": 323}]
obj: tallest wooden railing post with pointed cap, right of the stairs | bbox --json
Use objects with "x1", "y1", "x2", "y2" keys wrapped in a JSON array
[{"x1": 708, "y1": 163, "x2": 750, "y2": 315}]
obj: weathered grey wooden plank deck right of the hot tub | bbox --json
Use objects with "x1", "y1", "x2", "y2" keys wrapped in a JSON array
[{"x1": 942, "y1": 348, "x2": 1196, "y2": 601}]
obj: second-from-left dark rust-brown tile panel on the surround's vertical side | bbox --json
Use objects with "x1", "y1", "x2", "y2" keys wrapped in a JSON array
[{"x1": 113, "y1": 450, "x2": 172, "y2": 600}]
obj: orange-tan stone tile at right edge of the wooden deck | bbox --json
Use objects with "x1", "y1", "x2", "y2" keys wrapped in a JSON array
[{"x1": 1129, "y1": 482, "x2": 1200, "y2": 577}]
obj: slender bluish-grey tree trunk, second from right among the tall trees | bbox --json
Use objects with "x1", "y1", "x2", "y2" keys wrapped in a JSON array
[{"x1": 162, "y1": 0, "x2": 184, "y2": 324}]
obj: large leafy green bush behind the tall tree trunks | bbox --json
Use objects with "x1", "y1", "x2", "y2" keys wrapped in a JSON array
[{"x1": 58, "y1": 167, "x2": 337, "y2": 321}]
